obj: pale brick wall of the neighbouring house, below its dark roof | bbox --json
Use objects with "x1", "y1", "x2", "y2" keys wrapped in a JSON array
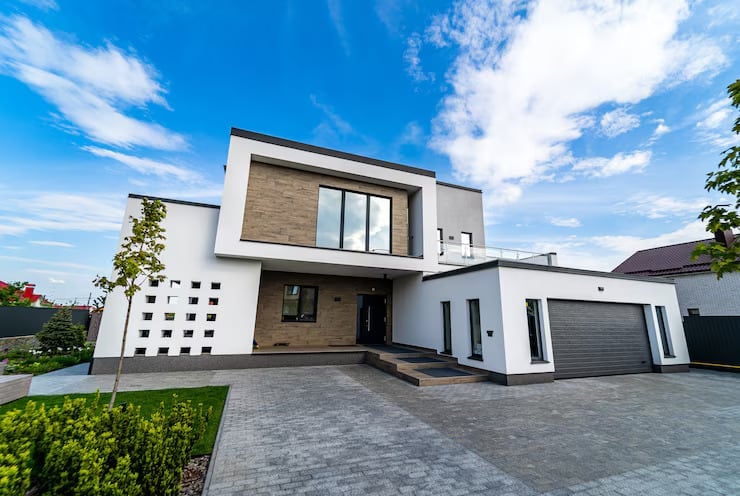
[{"x1": 673, "y1": 272, "x2": 740, "y2": 316}]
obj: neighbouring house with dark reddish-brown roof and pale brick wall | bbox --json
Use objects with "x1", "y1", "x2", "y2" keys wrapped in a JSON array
[{"x1": 612, "y1": 232, "x2": 740, "y2": 316}]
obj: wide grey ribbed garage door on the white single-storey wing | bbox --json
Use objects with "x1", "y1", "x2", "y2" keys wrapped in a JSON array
[{"x1": 547, "y1": 300, "x2": 652, "y2": 379}]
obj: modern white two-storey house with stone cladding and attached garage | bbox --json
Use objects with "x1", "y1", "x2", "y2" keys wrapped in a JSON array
[{"x1": 91, "y1": 129, "x2": 688, "y2": 384}]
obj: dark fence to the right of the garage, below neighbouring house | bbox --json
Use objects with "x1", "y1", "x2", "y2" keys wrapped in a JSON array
[{"x1": 683, "y1": 315, "x2": 740, "y2": 365}]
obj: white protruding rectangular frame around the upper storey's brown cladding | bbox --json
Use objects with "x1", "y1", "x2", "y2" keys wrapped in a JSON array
[{"x1": 215, "y1": 136, "x2": 437, "y2": 272}]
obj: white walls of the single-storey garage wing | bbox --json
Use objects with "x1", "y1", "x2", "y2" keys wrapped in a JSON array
[{"x1": 393, "y1": 267, "x2": 689, "y2": 374}]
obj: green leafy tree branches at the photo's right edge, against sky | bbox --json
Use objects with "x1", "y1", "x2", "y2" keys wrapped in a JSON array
[{"x1": 692, "y1": 79, "x2": 740, "y2": 279}]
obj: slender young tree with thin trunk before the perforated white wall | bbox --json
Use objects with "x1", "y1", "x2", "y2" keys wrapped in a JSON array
[{"x1": 93, "y1": 198, "x2": 167, "y2": 410}]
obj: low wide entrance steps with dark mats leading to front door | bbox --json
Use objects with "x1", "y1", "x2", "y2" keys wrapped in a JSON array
[{"x1": 367, "y1": 346, "x2": 489, "y2": 386}]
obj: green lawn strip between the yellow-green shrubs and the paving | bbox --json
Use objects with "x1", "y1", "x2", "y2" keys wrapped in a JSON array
[{"x1": 0, "y1": 386, "x2": 229, "y2": 456}]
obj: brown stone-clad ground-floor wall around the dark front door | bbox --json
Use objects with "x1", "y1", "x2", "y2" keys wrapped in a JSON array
[{"x1": 254, "y1": 271, "x2": 393, "y2": 348}]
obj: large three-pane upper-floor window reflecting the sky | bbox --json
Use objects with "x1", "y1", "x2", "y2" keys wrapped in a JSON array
[{"x1": 316, "y1": 186, "x2": 391, "y2": 253}]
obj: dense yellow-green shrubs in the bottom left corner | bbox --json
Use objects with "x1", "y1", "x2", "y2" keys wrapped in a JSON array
[{"x1": 0, "y1": 396, "x2": 210, "y2": 496}]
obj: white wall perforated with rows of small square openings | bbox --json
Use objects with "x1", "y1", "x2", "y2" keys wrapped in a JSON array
[{"x1": 95, "y1": 198, "x2": 261, "y2": 357}]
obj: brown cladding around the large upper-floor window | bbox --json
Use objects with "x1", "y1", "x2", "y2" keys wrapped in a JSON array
[{"x1": 241, "y1": 162, "x2": 409, "y2": 256}]
